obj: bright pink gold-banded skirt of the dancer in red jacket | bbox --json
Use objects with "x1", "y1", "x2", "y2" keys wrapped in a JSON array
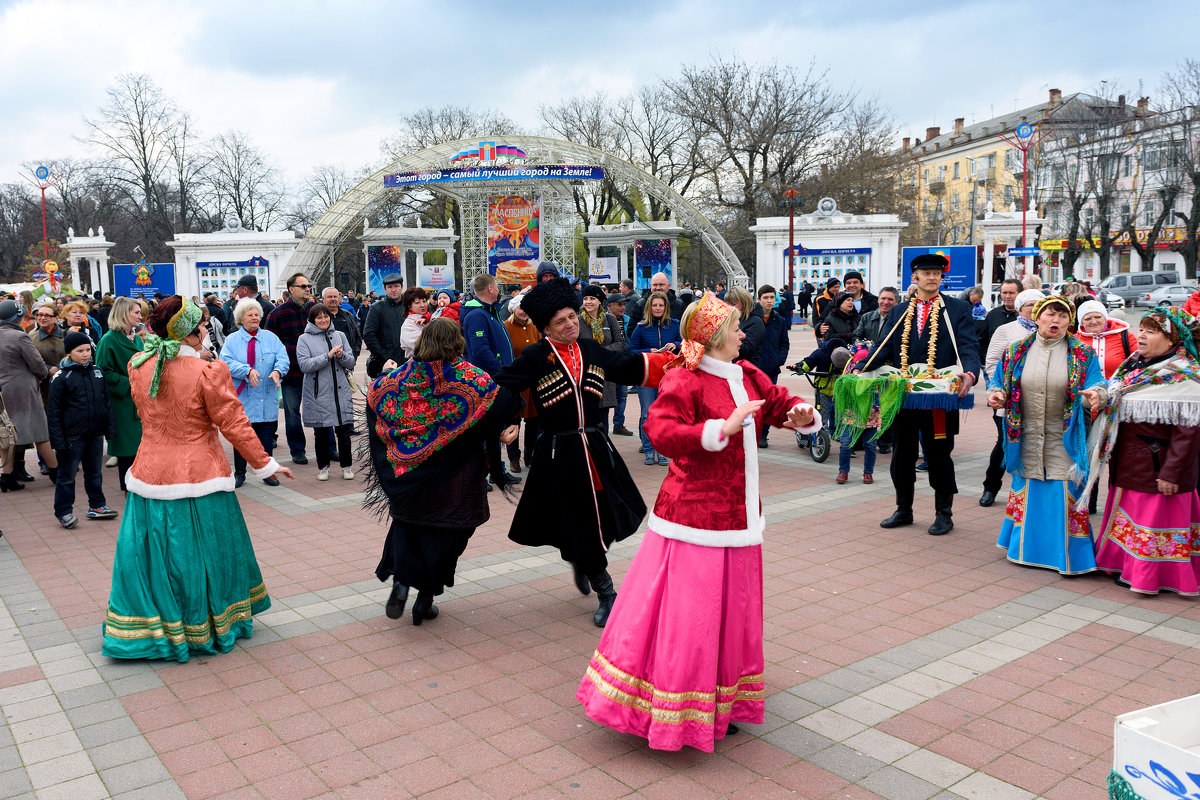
[{"x1": 575, "y1": 530, "x2": 764, "y2": 753}]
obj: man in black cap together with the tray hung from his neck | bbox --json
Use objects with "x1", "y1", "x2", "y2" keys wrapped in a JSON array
[{"x1": 862, "y1": 253, "x2": 980, "y2": 536}]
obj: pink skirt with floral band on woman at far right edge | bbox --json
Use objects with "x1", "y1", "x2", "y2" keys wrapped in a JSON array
[{"x1": 1096, "y1": 486, "x2": 1200, "y2": 596}]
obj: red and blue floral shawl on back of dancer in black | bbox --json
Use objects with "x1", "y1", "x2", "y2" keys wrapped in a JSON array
[{"x1": 367, "y1": 359, "x2": 499, "y2": 476}]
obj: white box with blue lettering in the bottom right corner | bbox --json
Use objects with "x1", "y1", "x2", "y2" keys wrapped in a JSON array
[{"x1": 1112, "y1": 694, "x2": 1200, "y2": 800}]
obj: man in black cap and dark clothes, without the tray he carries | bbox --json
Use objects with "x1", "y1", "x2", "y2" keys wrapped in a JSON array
[{"x1": 864, "y1": 253, "x2": 980, "y2": 536}]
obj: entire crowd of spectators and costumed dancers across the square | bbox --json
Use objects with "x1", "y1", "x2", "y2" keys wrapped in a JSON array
[{"x1": 0, "y1": 254, "x2": 1200, "y2": 751}]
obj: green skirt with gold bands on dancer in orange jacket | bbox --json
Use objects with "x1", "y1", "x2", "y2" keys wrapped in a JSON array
[{"x1": 102, "y1": 492, "x2": 271, "y2": 661}]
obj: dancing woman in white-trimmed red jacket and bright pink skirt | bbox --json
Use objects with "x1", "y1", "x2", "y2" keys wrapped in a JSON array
[{"x1": 576, "y1": 294, "x2": 821, "y2": 752}]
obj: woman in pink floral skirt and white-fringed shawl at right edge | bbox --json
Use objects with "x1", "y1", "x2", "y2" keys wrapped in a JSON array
[{"x1": 1082, "y1": 307, "x2": 1200, "y2": 596}]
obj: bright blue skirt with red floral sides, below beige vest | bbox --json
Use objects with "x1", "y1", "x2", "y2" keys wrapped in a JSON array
[{"x1": 996, "y1": 475, "x2": 1096, "y2": 575}]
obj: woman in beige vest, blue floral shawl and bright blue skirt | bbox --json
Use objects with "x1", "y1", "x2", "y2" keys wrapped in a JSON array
[{"x1": 988, "y1": 296, "x2": 1106, "y2": 575}]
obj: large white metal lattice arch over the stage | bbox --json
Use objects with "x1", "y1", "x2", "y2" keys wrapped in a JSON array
[{"x1": 287, "y1": 136, "x2": 750, "y2": 287}]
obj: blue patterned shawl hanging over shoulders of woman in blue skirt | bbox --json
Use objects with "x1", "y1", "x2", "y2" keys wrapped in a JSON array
[{"x1": 1000, "y1": 333, "x2": 1098, "y2": 482}]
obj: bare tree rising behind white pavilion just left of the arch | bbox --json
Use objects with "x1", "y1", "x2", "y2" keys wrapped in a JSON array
[{"x1": 205, "y1": 131, "x2": 284, "y2": 230}]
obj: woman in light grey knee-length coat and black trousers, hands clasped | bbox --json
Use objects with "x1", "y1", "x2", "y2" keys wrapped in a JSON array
[{"x1": 296, "y1": 307, "x2": 355, "y2": 481}]
